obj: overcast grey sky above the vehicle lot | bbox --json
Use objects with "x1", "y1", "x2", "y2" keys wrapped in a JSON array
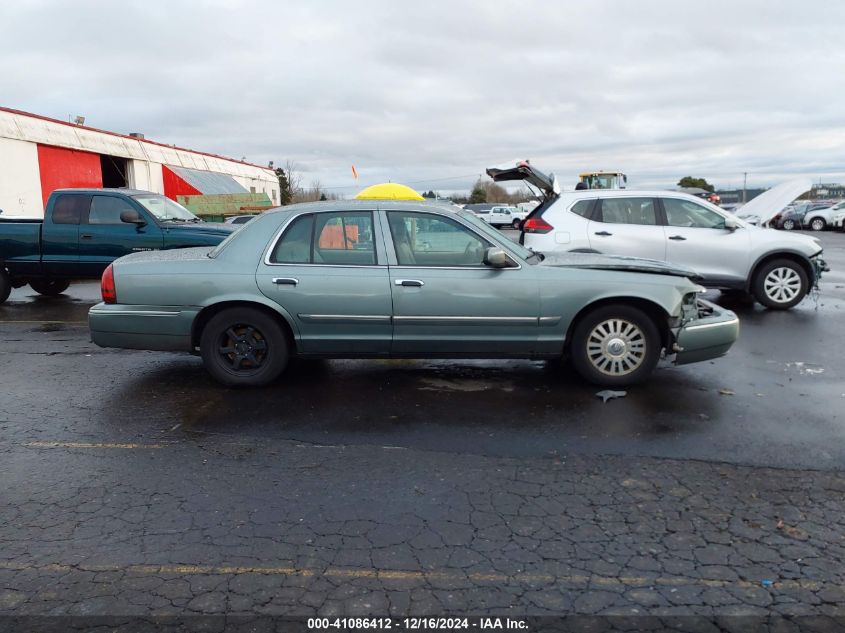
[{"x1": 0, "y1": 0, "x2": 845, "y2": 194}]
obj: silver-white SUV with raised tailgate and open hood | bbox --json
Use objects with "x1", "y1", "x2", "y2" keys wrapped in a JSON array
[{"x1": 487, "y1": 163, "x2": 828, "y2": 309}]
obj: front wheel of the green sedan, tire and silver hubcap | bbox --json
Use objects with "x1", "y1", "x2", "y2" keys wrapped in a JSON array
[{"x1": 570, "y1": 304, "x2": 661, "y2": 387}]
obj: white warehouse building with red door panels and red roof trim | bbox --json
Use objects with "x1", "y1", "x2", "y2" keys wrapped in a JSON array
[{"x1": 0, "y1": 107, "x2": 279, "y2": 218}]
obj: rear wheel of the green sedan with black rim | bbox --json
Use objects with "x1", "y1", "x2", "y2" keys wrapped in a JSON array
[{"x1": 200, "y1": 308, "x2": 289, "y2": 387}]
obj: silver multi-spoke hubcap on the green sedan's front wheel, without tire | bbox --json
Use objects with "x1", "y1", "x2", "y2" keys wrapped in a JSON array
[{"x1": 587, "y1": 319, "x2": 646, "y2": 376}]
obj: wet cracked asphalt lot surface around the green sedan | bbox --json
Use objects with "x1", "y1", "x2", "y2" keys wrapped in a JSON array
[{"x1": 0, "y1": 234, "x2": 845, "y2": 630}]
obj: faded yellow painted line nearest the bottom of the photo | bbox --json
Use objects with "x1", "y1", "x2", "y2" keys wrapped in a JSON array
[{"x1": 0, "y1": 561, "x2": 825, "y2": 591}]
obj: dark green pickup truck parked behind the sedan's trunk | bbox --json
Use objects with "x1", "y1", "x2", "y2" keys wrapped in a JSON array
[{"x1": 0, "y1": 189, "x2": 238, "y2": 303}]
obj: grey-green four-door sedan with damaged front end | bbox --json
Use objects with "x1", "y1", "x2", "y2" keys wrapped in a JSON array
[{"x1": 89, "y1": 200, "x2": 739, "y2": 387}]
